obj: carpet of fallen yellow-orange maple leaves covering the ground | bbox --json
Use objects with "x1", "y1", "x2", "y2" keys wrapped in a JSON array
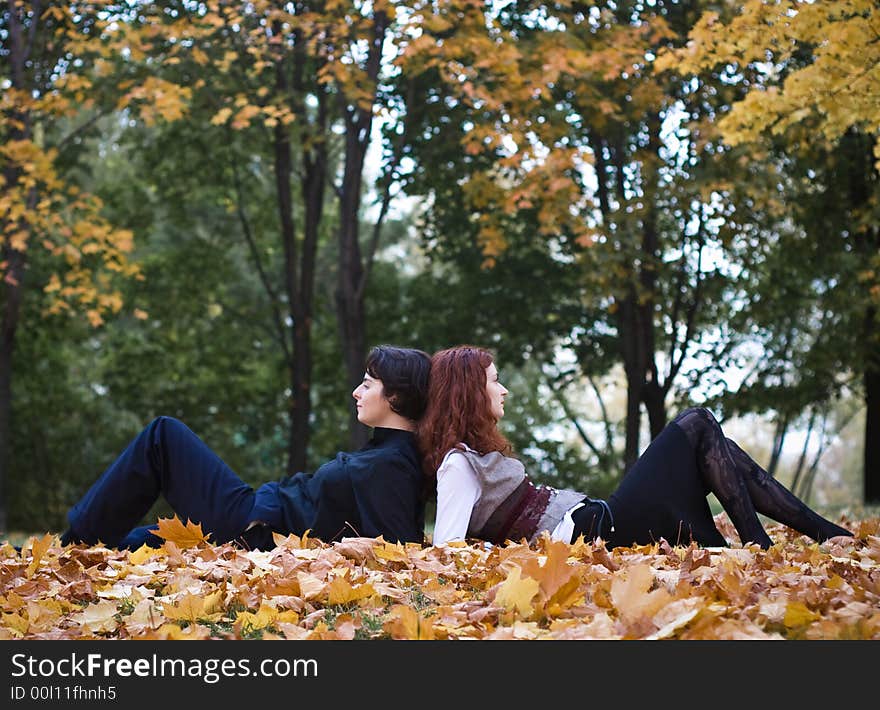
[{"x1": 0, "y1": 514, "x2": 880, "y2": 639}]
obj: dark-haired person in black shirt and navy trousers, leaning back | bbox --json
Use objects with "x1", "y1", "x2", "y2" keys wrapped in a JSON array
[{"x1": 61, "y1": 346, "x2": 431, "y2": 549}]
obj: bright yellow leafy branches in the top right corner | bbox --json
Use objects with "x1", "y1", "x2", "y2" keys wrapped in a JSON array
[{"x1": 656, "y1": 0, "x2": 880, "y2": 168}]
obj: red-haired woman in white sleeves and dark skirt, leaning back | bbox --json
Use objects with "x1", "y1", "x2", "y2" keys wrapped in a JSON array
[{"x1": 418, "y1": 346, "x2": 852, "y2": 549}]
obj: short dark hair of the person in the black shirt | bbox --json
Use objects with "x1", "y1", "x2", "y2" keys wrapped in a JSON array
[{"x1": 366, "y1": 345, "x2": 431, "y2": 421}]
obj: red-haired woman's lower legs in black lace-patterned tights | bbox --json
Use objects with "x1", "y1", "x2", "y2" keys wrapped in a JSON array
[{"x1": 674, "y1": 408, "x2": 852, "y2": 549}]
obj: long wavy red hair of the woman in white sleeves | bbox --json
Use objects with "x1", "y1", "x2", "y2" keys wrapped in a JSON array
[{"x1": 416, "y1": 345, "x2": 512, "y2": 495}]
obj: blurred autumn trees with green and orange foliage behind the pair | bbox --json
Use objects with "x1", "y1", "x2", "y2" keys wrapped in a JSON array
[{"x1": 0, "y1": 0, "x2": 880, "y2": 531}]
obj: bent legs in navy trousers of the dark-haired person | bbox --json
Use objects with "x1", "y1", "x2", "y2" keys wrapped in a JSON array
[{"x1": 66, "y1": 417, "x2": 254, "y2": 546}]
